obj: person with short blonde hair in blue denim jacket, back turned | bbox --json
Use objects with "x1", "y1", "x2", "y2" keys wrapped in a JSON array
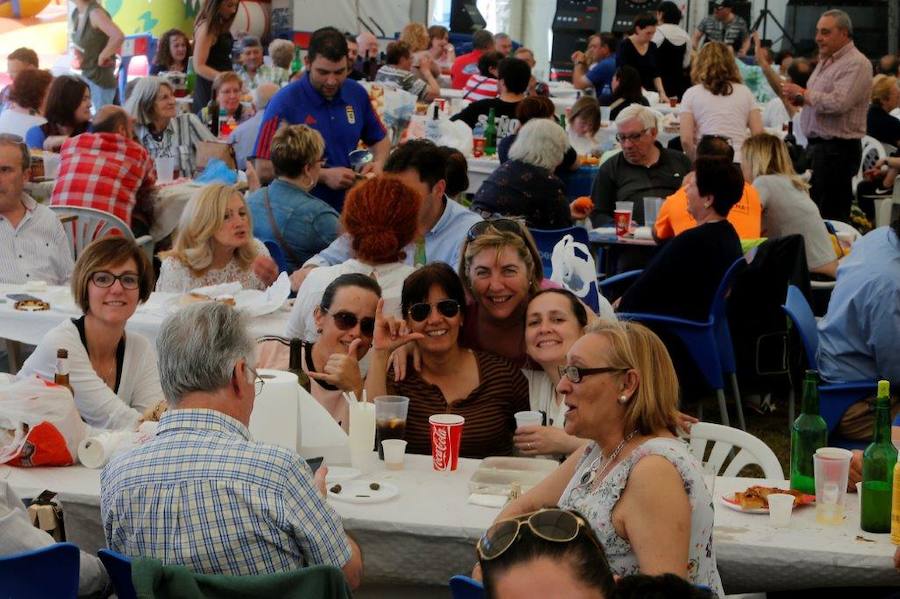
[{"x1": 247, "y1": 125, "x2": 340, "y2": 272}]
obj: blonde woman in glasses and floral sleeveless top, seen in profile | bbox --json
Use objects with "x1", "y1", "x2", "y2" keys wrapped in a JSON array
[{"x1": 478, "y1": 320, "x2": 723, "y2": 596}]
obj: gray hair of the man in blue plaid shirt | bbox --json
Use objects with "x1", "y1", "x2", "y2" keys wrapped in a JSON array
[{"x1": 156, "y1": 302, "x2": 256, "y2": 406}]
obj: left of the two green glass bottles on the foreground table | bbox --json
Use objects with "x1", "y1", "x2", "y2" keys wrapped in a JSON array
[{"x1": 791, "y1": 370, "x2": 828, "y2": 495}]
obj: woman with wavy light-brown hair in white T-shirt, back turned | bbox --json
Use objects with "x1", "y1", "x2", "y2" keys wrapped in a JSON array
[{"x1": 679, "y1": 42, "x2": 763, "y2": 162}]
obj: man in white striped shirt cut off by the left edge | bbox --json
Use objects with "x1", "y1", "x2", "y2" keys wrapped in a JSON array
[{"x1": 0, "y1": 134, "x2": 73, "y2": 285}]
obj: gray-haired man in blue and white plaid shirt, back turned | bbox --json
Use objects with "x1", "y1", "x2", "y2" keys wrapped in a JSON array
[{"x1": 100, "y1": 303, "x2": 362, "y2": 588}]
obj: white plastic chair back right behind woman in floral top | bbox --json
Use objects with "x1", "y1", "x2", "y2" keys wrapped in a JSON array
[{"x1": 690, "y1": 422, "x2": 784, "y2": 480}]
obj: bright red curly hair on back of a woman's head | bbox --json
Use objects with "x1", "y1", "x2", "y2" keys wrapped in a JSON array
[{"x1": 341, "y1": 175, "x2": 422, "y2": 264}]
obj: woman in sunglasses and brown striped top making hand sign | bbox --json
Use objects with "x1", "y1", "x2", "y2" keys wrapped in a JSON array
[{"x1": 366, "y1": 262, "x2": 528, "y2": 458}]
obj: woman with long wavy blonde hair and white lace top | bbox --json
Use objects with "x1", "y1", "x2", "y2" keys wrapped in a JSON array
[{"x1": 156, "y1": 183, "x2": 278, "y2": 293}]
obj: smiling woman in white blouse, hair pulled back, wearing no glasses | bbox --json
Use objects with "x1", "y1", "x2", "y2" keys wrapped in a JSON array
[{"x1": 514, "y1": 289, "x2": 588, "y2": 456}]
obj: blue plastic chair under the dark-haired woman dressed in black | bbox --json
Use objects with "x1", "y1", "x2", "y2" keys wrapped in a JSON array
[{"x1": 616, "y1": 257, "x2": 747, "y2": 430}]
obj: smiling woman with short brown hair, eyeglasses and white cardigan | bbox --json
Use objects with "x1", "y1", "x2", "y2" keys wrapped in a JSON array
[{"x1": 19, "y1": 237, "x2": 163, "y2": 429}]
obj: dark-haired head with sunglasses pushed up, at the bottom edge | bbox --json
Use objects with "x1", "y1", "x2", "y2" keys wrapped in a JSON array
[{"x1": 476, "y1": 508, "x2": 616, "y2": 599}]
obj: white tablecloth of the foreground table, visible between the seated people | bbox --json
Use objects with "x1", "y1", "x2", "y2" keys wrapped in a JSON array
[{"x1": 0, "y1": 464, "x2": 900, "y2": 593}]
